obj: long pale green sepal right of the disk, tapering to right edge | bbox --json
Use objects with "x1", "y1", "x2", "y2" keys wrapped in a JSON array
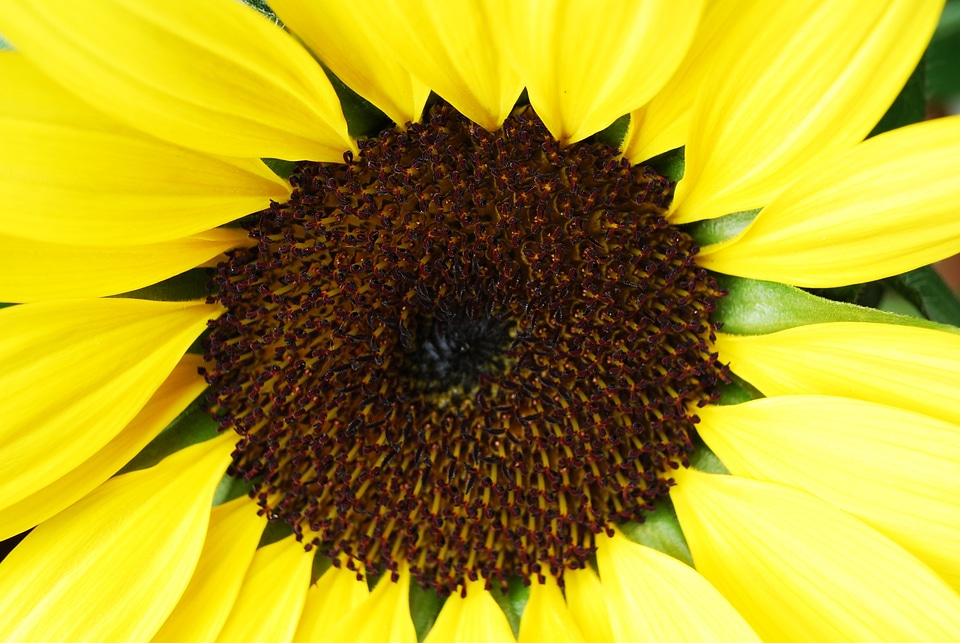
[{"x1": 712, "y1": 275, "x2": 960, "y2": 335}]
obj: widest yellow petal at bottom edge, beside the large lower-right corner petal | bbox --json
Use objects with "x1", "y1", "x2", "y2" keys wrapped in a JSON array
[{"x1": 597, "y1": 531, "x2": 758, "y2": 643}]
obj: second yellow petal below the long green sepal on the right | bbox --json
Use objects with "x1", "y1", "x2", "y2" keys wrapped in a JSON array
[{"x1": 697, "y1": 395, "x2": 960, "y2": 589}]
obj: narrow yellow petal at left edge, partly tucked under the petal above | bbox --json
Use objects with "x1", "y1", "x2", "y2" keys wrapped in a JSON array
[{"x1": 0, "y1": 228, "x2": 247, "y2": 302}]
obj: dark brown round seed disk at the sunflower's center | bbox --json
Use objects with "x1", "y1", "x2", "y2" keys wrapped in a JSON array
[{"x1": 206, "y1": 104, "x2": 725, "y2": 594}]
